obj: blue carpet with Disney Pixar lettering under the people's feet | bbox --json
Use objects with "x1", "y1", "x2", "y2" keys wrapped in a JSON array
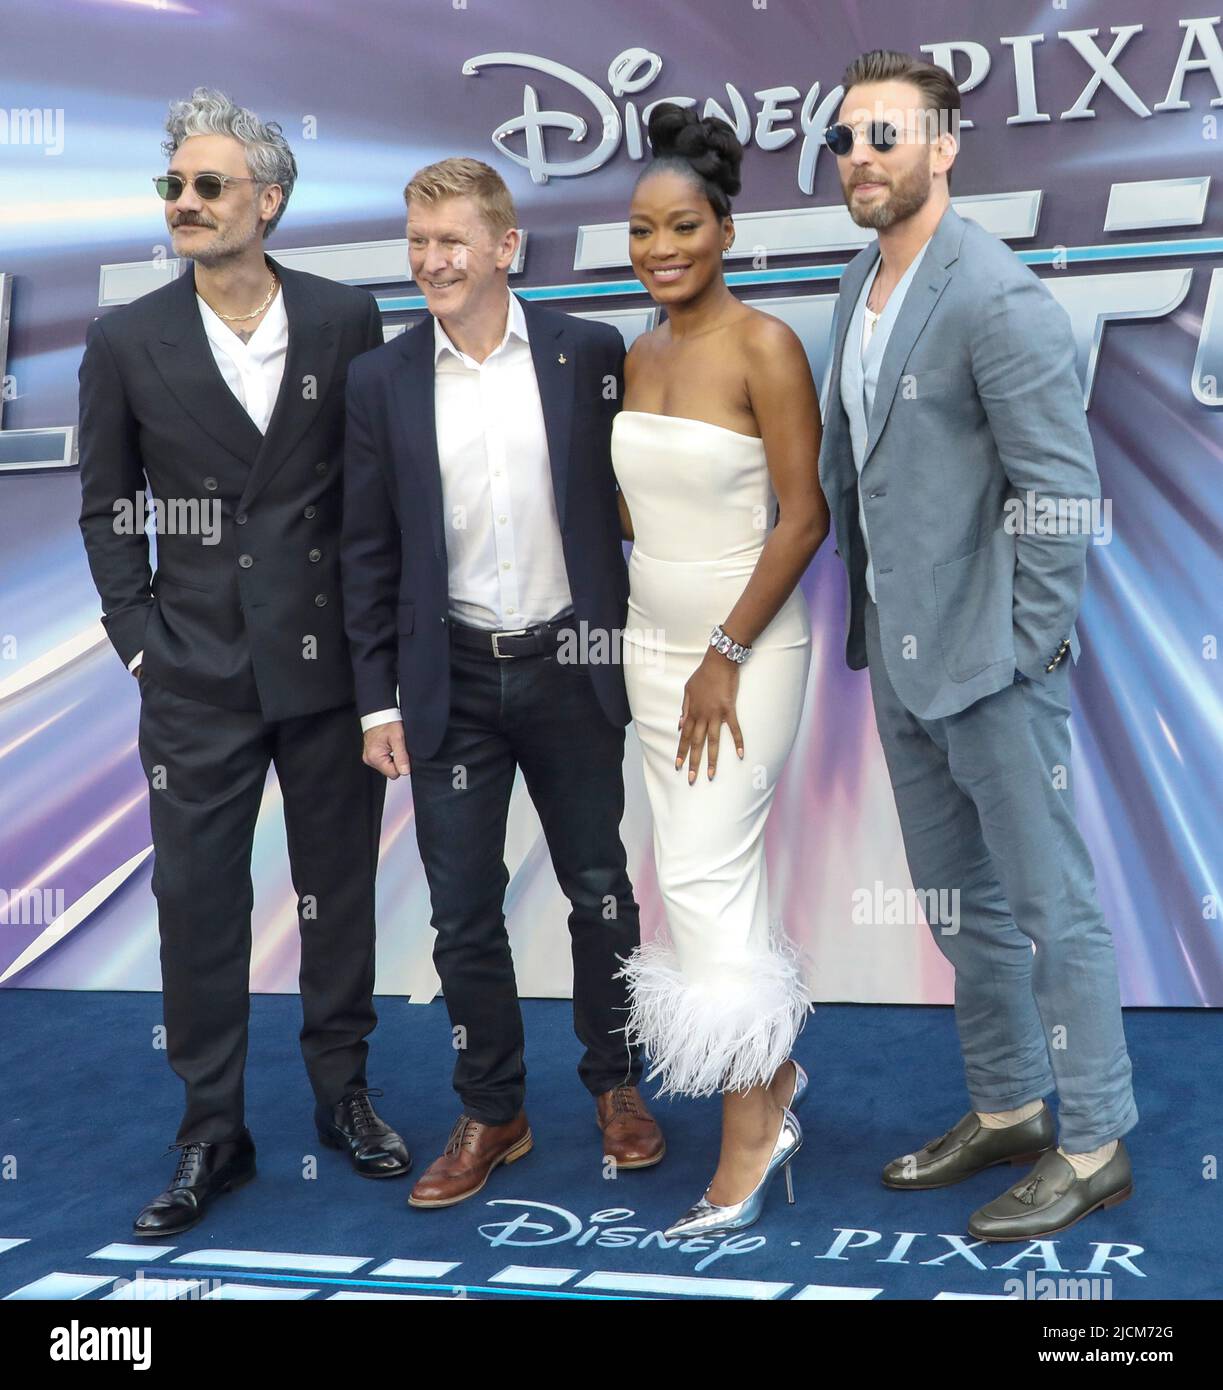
[{"x1": 0, "y1": 990, "x2": 1223, "y2": 1300}]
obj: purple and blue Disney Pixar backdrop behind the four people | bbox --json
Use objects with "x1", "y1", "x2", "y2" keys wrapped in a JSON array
[{"x1": 0, "y1": 0, "x2": 1223, "y2": 1005}]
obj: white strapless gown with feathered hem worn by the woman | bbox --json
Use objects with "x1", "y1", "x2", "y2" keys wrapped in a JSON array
[{"x1": 612, "y1": 410, "x2": 812, "y2": 1095}]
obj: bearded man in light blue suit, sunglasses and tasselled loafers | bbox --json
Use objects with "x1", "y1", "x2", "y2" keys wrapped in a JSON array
[{"x1": 820, "y1": 51, "x2": 1138, "y2": 1240}]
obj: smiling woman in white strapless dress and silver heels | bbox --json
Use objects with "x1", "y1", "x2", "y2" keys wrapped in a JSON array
[{"x1": 612, "y1": 103, "x2": 828, "y2": 1236}]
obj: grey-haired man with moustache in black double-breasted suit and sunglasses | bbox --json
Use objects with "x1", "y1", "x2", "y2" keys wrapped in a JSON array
[{"x1": 81, "y1": 88, "x2": 410, "y2": 1237}]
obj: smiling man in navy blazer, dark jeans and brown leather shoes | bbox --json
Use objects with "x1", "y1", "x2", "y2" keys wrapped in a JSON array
[{"x1": 342, "y1": 158, "x2": 664, "y2": 1207}]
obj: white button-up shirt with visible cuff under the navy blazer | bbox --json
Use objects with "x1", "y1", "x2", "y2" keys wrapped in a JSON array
[{"x1": 361, "y1": 293, "x2": 573, "y2": 728}]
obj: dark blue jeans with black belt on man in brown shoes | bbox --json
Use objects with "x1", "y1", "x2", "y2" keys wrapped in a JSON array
[{"x1": 411, "y1": 644, "x2": 641, "y2": 1125}]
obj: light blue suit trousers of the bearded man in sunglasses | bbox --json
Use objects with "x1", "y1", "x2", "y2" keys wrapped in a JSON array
[{"x1": 866, "y1": 599, "x2": 1138, "y2": 1154}]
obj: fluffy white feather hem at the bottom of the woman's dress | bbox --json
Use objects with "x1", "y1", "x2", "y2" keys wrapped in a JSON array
[{"x1": 617, "y1": 930, "x2": 812, "y2": 1097}]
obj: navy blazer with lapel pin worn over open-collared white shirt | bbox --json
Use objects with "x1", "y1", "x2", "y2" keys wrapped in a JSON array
[{"x1": 340, "y1": 300, "x2": 630, "y2": 758}]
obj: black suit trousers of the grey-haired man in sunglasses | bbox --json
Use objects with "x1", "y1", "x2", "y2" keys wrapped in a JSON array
[{"x1": 139, "y1": 671, "x2": 385, "y2": 1143}]
